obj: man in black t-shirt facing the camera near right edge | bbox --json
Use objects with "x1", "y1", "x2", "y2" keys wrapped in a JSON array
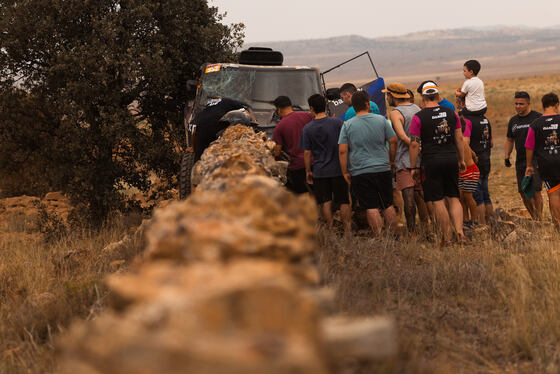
[{"x1": 504, "y1": 91, "x2": 543, "y2": 220}]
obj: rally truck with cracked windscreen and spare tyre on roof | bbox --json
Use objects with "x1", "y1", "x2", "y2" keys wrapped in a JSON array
[{"x1": 179, "y1": 48, "x2": 324, "y2": 199}]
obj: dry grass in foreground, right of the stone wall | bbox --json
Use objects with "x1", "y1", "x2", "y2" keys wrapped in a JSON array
[{"x1": 320, "y1": 226, "x2": 560, "y2": 373}]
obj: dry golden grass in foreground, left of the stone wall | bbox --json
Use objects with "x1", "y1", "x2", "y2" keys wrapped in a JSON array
[{"x1": 0, "y1": 215, "x2": 144, "y2": 373}]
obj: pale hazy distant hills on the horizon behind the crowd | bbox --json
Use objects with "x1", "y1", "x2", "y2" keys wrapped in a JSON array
[{"x1": 248, "y1": 26, "x2": 560, "y2": 85}]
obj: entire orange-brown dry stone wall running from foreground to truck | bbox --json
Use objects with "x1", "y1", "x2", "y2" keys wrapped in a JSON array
[{"x1": 60, "y1": 126, "x2": 396, "y2": 374}]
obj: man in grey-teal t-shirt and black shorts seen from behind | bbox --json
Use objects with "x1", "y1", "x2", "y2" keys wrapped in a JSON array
[{"x1": 338, "y1": 91, "x2": 397, "y2": 235}]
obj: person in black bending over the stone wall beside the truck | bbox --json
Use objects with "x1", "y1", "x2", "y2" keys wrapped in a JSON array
[{"x1": 193, "y1": 98, "x2": 245, "y2": 162}]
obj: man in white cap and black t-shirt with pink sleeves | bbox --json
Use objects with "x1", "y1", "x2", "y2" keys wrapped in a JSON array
[{"x1": 410, "y1": 81, "x2": 466, "y2": 245}]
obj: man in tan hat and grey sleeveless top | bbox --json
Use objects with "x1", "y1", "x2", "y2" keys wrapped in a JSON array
[{"x1": 383, "y1": 83, "x2": 428, "y2": 232}]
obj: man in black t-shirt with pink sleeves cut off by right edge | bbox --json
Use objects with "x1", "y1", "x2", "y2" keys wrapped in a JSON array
[{"x1": 525, "y1": 93, "x2": 560, "y2": 231}]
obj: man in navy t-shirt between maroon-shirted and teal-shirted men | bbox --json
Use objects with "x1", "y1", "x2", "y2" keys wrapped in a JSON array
[{"x1": 300, "y1": 94, "x2": 351, "y2": 233}]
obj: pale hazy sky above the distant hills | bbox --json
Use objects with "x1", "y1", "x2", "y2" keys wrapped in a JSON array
[{"x1": 208, "y1": 0, "x2": 560, "y2": 43}]
